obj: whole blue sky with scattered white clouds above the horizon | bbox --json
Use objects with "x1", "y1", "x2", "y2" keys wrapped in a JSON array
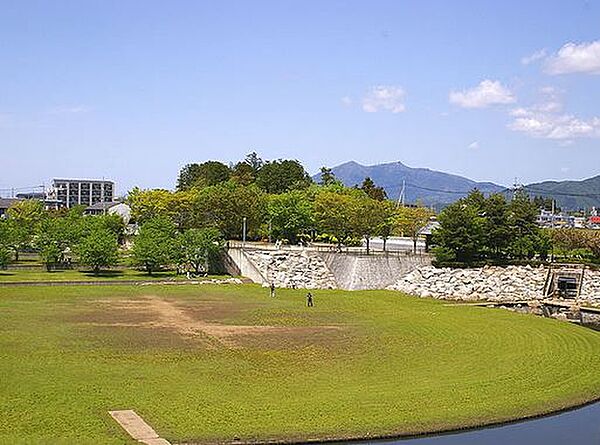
[{"x1": 0, "y1": 0, "x2": 600, "y2": 193}]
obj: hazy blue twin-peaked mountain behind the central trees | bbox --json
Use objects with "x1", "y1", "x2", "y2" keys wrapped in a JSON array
[{"x1": 314, "y1": 161, "x2": 506, "y2": 208}]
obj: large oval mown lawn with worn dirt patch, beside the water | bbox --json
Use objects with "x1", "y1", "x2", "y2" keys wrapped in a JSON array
[{"x1": 0, "y1": 285, "x2": 600, "y2": 444}]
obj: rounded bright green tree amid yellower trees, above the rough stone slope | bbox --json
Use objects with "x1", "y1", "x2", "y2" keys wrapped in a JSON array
[{"x1": 267, "y1": 190, "x2": 314, "y2": 243}]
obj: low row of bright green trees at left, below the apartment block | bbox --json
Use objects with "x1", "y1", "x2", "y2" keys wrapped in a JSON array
[{"x1": 0, "y1": 200, "x2": 224, "y2": 274}]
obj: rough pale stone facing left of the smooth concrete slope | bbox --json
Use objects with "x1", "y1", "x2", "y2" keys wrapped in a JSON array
[{"x1": 245, "y1": 250, "x2": 337, "y2": 289}]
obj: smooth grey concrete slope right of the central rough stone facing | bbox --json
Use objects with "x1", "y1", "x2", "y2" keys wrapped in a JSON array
[{"x1": 317, "y1": 252, "x2": 431, "y2": 290}]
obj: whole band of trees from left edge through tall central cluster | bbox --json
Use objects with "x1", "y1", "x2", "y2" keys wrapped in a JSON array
[{"x1": 0, "y1": 153, "x2": 433, "y2": 273}]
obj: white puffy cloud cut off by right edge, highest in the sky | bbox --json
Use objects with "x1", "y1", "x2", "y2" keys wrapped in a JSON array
[{"x1": 545, "y1": 40, "x2": 600, "y2": 74}]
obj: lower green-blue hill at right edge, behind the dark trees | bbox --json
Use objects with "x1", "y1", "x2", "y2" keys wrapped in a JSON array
[{"x1": 525, "y1": 175, "x2": 600, "y2": 210}]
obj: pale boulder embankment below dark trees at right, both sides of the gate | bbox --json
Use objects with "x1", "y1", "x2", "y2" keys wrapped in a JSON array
[{"x1": 388, "y1": 266, "x2": 600, "y2": 306}]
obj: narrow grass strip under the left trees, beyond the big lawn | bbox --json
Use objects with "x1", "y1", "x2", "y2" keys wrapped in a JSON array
[{"x1": 0, "y1": 269, "x2": 230, "y2": 283}]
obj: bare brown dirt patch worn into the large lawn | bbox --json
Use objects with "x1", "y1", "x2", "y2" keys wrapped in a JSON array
[{"x1": 77, "y1": 296, "x2": 344, "y2": 348}]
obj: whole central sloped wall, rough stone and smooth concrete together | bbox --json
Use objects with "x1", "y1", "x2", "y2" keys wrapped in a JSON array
[{"x1": 225, "y1": 247, "x2": 431, "y2": 290}]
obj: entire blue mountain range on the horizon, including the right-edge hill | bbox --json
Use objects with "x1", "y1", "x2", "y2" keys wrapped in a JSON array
[{"x1": 322, "y1": 161, "x2": 600, "y2": 210}]
